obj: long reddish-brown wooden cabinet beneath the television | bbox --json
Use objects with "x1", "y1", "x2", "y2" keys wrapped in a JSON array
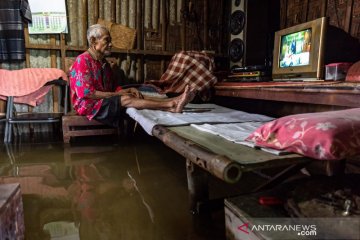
[{"x1": 215, "y1": 81, "x2": 360, "y2": 117}]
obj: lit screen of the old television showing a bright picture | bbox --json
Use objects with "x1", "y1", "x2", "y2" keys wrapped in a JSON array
[{"x1": 279, "y1": 28, "x2": 311, "y2": 68}]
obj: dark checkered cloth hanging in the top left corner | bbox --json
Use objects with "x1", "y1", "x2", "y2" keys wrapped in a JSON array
[{"x1": 0, "y1": 0, "x2": 31, "y2": 62}]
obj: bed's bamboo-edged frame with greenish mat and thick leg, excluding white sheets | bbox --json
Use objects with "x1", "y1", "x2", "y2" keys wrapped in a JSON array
[{"x1": 149, "y1": 126, "x2": 311, "y2": 213}]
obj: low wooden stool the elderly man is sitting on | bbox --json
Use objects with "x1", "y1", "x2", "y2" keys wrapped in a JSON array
[{"x1": 62, "y1": 112, "x2": 119, "y2": 143}]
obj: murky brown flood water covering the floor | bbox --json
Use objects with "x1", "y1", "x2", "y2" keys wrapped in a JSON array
[{"x1": 0, "y1": 134, "x2": 225, "y2": 240}]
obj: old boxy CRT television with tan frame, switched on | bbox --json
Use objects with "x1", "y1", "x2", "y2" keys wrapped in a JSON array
[{"x1": 272, "y1": 17, "x2": 328, "y2": 81}]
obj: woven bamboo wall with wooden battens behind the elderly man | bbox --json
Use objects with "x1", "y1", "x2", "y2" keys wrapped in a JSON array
[{"x1": 0, "y1": 0, "x2": 227, "y2": 135}]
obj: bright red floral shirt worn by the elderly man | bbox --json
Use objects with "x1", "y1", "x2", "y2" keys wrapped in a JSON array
[{"x1": 70, "y1": 52, "x2": 113, "y2": 120}]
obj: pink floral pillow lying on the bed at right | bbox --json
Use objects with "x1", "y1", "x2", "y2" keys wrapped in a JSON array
[{"x1": 247, "y1": 108, "x2": 360, "y2": 160}]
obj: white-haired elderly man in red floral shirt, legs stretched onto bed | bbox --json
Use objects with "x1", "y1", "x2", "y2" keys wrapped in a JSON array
[{"x1": 70, "y1": 24, "x2": 194, "y2": 127}]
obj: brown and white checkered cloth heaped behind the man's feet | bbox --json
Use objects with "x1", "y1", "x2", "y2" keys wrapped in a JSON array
[{"x1": 148, "y1": 51, "x2": 217, "y2": 101}]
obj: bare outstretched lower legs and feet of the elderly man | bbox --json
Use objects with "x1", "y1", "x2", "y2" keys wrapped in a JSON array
[{"x1": 120, "y1": 86, "x2": 194, "y2": 113}]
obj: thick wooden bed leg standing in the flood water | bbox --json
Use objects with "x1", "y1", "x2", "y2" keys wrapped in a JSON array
[{"x1": 186, "y1": 159, "x2": 209, "y2": 214}]
